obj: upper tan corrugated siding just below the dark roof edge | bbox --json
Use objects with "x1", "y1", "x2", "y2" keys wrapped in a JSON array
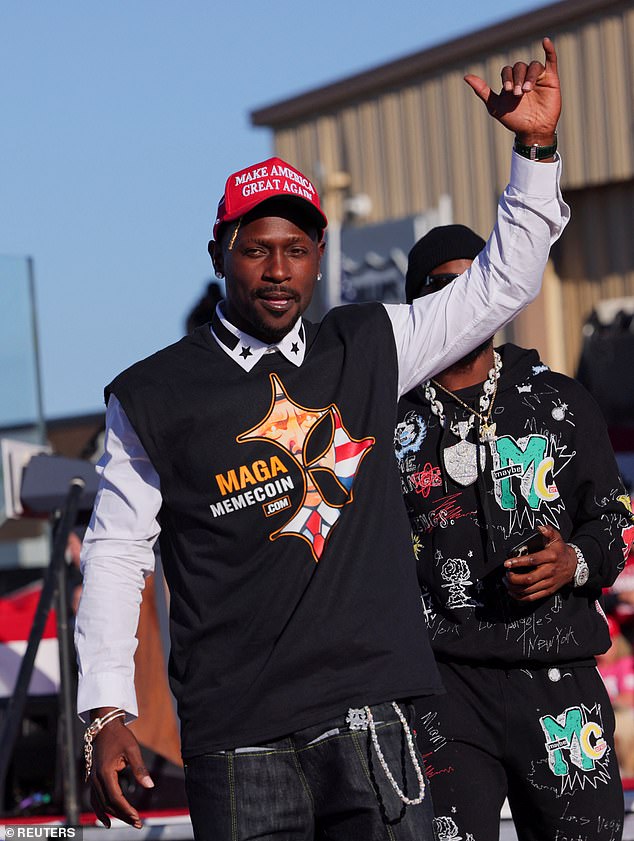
[{"x1": 266, "y1": 3, "x2": 634, "y2": 213}]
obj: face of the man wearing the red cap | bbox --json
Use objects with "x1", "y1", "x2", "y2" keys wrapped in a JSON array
[{"x1": 210, "y1": 206, "x2": 324, "y2": 344}]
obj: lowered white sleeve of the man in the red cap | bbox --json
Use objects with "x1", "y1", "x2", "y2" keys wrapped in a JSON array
[{"x1": 75, "y1": 395, "x2": 161, "y2": 720}]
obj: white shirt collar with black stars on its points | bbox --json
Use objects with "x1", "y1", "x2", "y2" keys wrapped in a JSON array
[{"x1": 211, "y1": 304, "x2": 306, "y2": 371}]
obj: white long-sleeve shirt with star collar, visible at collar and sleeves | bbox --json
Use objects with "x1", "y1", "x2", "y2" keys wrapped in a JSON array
[{"x1": 75, "y1": 153, "x2": 569, "y2": 718}]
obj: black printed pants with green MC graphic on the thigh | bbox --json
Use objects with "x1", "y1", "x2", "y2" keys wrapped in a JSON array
[{"x1": 414, "y1": 663, "x2": 624, "y2": 841}]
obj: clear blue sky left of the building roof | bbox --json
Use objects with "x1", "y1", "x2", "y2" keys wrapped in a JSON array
[{"x1": 0, "y1": 0, "x2": 547, "y2": 417}]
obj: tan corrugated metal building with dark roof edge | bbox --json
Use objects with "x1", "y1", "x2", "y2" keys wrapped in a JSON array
[{"x1": 251, "y1": 0, "x2": 634, "y2": 373}]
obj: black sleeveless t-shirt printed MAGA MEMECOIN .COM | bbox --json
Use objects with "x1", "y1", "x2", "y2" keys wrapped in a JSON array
[{"x1": 109, "y1": 305, "x2": 440, "y2": 757}]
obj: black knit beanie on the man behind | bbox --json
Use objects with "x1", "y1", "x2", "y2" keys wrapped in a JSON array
[{"x1": 405, "y1": 225, "x2": 486, "y2": 304}]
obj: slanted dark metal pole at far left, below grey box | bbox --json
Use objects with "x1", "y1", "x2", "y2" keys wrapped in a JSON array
[{"x1": 0, "y1": 477, "x2": 86, "y2": 811}]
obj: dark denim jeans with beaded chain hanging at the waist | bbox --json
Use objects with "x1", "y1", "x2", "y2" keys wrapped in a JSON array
[{"x1": 185, "y1": 704, "x2": 434, "y2": 841}]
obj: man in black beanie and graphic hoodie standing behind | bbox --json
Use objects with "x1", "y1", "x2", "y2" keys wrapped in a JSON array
[{"x1": 395, "y1": 225, "x2": 632, "y2": 841}]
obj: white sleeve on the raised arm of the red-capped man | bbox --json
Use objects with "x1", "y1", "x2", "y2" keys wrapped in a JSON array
[{"x1": 385, "y1": 152, "x2": 570, "y2": 395}]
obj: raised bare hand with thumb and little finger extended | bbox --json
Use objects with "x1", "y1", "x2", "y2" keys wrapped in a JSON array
[{"x1": 464, "y1": 38, "x2": 561, "y2": 146}]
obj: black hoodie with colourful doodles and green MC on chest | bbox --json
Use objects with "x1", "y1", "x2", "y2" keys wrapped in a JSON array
[{"x1": 395, "y1": 344, "x2": 634, "y2": 666}]
